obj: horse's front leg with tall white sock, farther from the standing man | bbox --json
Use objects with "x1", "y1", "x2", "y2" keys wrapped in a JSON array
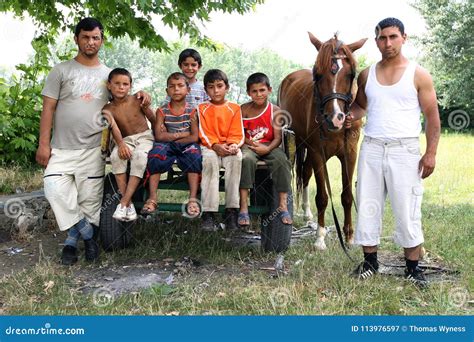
[{"x1": 313, "y1": 156, "x2": 328, "y2": 250}]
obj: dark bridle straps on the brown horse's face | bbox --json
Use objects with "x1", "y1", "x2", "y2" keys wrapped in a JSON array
[{"x1": 313, "y1": 40, "x2": 355, "y2": 122}]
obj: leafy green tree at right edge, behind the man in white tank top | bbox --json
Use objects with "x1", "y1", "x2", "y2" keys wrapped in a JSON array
[{"x1": 413, "y1": 0, "x2": 474, "y2": 128}]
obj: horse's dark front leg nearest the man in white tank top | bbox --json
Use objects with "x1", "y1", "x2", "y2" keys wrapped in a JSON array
[{"x1": 338, "y1": 151, "x2": 357, "y2": 245}]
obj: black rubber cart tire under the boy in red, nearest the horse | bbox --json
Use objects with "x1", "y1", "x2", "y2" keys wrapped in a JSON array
[{"x1": 260, "y1": 184, "x2": 293, "y2": 253}]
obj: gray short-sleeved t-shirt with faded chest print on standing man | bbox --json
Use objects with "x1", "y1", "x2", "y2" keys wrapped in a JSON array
[{"x1": 41, "y1": 59, "x2": 110, "y2": 150}]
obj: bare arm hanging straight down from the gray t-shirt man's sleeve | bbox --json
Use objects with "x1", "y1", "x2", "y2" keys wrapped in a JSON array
[{"x1": 36, "y1": 96, "x2": 58, "y2": 167}]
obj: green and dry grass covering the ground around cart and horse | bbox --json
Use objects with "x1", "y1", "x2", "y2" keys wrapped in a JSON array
[{"x1": 0, "y1": 134, "x2": 474, "y2": 315}]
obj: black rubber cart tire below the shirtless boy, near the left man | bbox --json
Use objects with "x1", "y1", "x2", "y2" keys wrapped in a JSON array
[{"x1": 99, "y1": 173, "x2": 133, "y2": 252}]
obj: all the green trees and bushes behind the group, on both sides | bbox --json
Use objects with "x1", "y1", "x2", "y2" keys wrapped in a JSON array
[{"x1": 0, "y1": 0, "x2": 474, "y2": 165}]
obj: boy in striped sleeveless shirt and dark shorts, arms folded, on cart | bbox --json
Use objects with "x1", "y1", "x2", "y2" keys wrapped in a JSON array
[{"x1": 142, "y1": 72, "x2": 202, "y2": 218}]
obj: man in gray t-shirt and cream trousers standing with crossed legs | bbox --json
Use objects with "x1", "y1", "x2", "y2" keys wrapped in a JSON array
[{"x1": 36, "y1": 18, "x2": 150, "y2": 265}]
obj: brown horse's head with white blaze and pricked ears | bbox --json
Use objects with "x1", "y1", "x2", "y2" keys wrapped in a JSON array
[{"x1": 308, "y1": 32, "x2": 367, "y2": 131}]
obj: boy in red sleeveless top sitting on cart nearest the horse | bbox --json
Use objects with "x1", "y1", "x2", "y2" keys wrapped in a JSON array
[{"x1": 238, "y1": 72, "x2": 293, "y2": 228}]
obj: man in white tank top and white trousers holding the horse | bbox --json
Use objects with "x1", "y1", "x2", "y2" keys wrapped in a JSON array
[{"x1": 346, "y1": 18, "x2": 440, "y2": 287}]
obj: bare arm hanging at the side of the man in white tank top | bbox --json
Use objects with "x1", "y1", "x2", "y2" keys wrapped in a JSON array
[{"x1": 415, "y1": 67, "x2": 441, "y2": 178}]
